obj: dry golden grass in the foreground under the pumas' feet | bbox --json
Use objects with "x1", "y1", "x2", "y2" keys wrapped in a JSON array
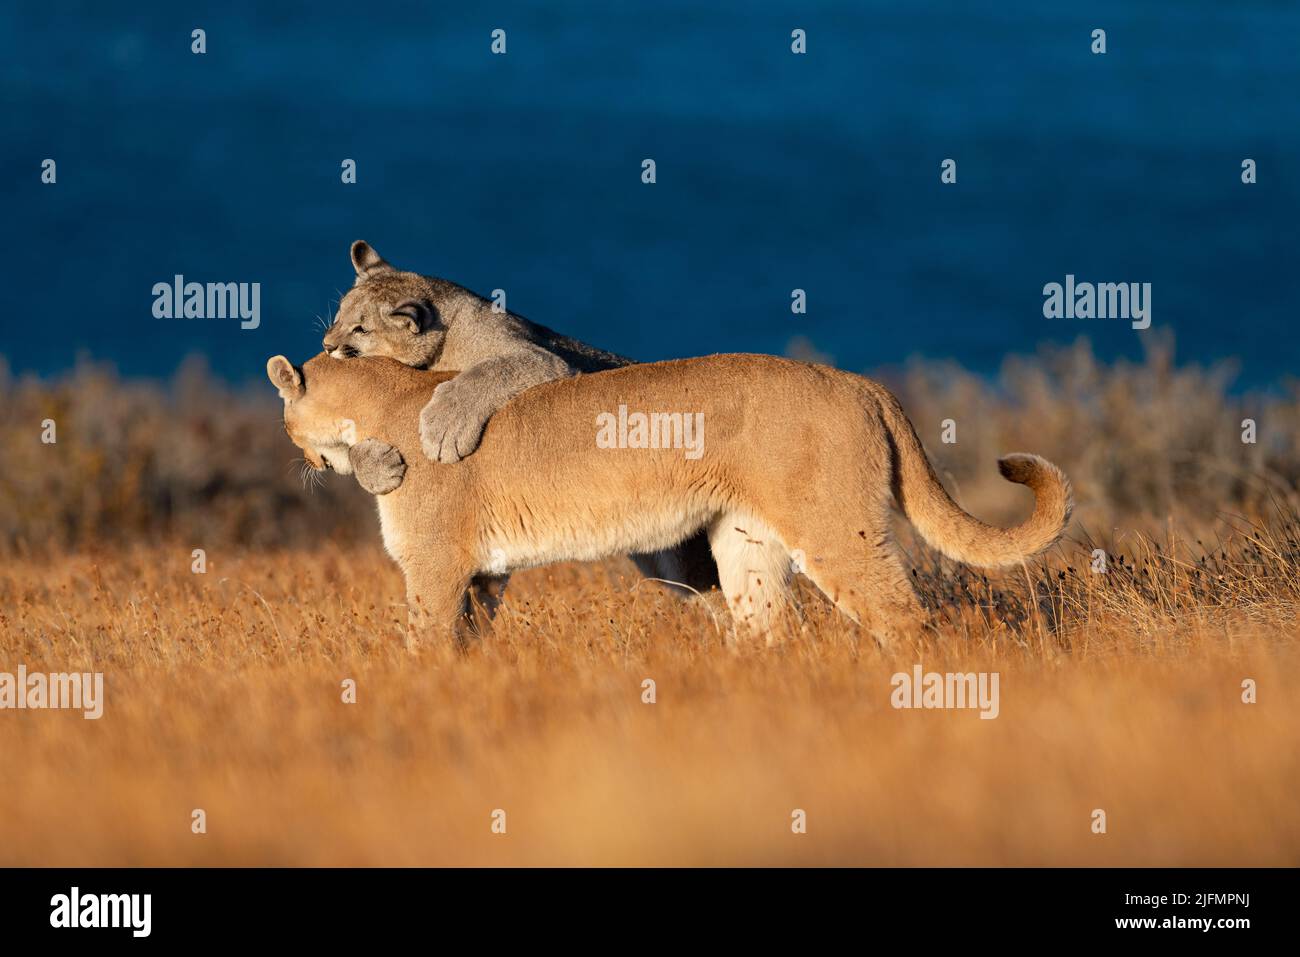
[{"x1": 0, "y1": 523, "x2": 1300, "y2": 865}]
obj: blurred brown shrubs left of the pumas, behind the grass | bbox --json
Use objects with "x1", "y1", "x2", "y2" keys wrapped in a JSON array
[{"x1": 0, "y1": 360, "x2": 374, "y2": 550}]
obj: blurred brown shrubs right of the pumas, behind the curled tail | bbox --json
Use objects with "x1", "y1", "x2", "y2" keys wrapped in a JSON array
[{"x1": 894, "y1": 337, "x2": 1300, "y2": 534}]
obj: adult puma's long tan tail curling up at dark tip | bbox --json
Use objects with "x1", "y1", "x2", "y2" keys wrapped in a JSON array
[{"x1": 879, "y1": 390, "x2": 1074, "y2": 568}]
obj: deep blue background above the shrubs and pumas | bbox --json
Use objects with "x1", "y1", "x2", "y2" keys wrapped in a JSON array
[{"x1": 0, "y1": 0, "x2": 1300, "y2": 385}]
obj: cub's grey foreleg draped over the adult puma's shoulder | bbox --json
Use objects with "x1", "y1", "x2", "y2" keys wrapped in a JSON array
[{"x1": 420, "y1": 347, "x2": 573, "y2": 465}]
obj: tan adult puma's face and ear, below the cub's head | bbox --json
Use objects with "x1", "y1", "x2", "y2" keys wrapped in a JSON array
[{"x1": 267, "y1": 355, "x2": 356, "y2": 475}]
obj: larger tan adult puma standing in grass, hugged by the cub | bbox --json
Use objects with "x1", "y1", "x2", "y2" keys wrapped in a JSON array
[{"x1": 268, "y1": 355, "x2": 1071, "y2": 642}]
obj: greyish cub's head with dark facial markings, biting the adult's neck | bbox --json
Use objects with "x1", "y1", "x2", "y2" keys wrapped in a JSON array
[{"x1": 321, "y1": 239, "x2": 465, "y2": 368}]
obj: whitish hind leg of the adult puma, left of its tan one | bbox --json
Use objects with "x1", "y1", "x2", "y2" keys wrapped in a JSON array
[{"x1": 709, "y1": 512, "x2": 792, "y2": 641}]
